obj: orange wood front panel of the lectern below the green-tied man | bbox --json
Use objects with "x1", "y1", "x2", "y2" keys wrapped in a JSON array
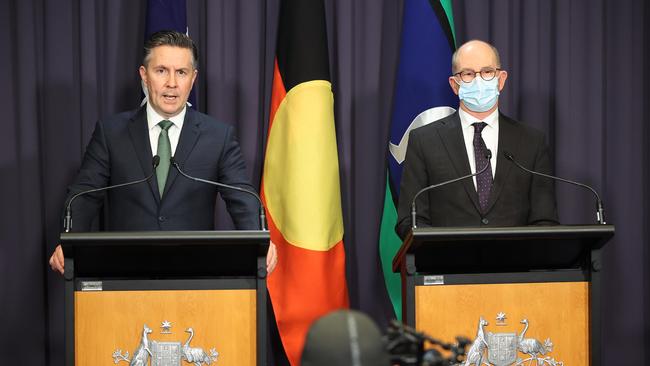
[{"x1": 74, "y1": 289, "x2": 256, "y2": 366}]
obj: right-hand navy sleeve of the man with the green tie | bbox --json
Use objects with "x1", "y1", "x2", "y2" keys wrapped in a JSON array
[{"x1": 218, "y1": 126, "x2": 261, "y2": 230}]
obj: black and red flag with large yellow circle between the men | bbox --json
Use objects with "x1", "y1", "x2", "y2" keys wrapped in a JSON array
[{"x1": 261, "y1": 0, "x2": 349, "y2": 366}]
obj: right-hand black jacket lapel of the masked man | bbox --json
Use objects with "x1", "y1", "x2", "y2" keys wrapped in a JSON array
[{"x1": 485, "y1": 114, "x2": 521, "y2": 213}]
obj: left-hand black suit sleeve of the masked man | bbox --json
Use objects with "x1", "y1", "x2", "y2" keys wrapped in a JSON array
[{"x1": 395, "y1": 130, "x2": 431, "y2": 240}]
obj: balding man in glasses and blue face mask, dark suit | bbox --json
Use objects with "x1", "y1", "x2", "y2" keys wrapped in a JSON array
[{"x1": 396, "y1": 40, "x2": 558, "y2": 239}]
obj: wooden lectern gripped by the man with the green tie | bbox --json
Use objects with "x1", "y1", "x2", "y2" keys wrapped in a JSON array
[{"x1": 61, "y1": 231, "x2": 269, "y2": 366}]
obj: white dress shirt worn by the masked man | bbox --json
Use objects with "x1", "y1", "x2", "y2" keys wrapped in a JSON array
[{"x1": 458, "y1": 108, "x2": 499, "y2": 188}]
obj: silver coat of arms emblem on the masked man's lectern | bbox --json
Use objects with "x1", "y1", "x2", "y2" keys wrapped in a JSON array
[{"x1": 463, "y1": 313, "x2": 564, "y2": 366}]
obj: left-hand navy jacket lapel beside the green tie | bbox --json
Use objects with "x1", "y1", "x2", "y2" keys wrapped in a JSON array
[{"x1": 128, "y1": 107, "x2": 160, "y2": 203}]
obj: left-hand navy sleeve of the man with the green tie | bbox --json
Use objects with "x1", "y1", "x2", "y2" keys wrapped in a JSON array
[{"x1": 63, "y1": 121, "x2": 110, "y2": 231}]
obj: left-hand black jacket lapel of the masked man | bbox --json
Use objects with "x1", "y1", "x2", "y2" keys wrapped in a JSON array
[{"x1": 436, "y1": 112, "x2": 481, "y2": 212}]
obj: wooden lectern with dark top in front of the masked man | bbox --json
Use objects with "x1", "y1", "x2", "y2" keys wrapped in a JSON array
[{"x1": 393, "y1": 225, "x2": 614, "y2": 365}]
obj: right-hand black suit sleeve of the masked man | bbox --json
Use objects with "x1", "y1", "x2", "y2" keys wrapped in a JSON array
[{"x1": 528, "y1": 134, "x2": 559, "y2": 225}]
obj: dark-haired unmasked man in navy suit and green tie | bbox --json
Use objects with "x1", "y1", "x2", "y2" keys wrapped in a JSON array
[{"x1": 50, "y1": 31, "x2": 277, "y2": 273}]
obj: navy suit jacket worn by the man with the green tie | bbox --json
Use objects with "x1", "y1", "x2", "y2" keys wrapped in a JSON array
[{"x1": 66, "y1": 107, "x2": 259, "y2": 231}]
